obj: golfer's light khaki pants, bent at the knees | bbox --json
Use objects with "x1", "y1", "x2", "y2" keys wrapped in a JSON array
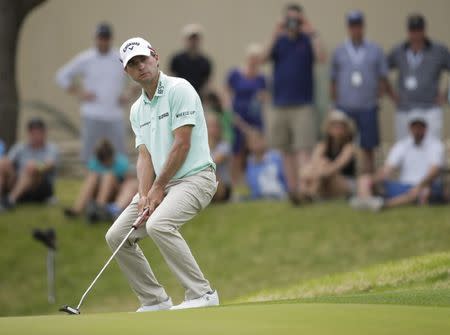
[{"x1": 106, "y1": 169, "x2": 217, "y2": 306}]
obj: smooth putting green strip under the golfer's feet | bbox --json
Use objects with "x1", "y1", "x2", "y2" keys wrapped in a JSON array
[{"x1": 0, "y1": 303, "x2": 450, "y2": 335}]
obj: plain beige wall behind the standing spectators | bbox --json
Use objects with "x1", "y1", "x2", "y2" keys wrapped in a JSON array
[{"x1": 18, "y1": 0, "x2": 450, "y2": 140}]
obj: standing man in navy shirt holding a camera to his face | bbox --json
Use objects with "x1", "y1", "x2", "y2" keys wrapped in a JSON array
[{"x1": 265, "y1": 5, "x2": 325, "y2": 203}]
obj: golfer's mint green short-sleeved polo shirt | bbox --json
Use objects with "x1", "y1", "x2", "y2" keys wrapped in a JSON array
[{"x1": 130, "y1": 72, "x2": 215, "y2": 179}]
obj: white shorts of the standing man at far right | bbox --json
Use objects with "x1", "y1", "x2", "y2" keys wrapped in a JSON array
[{"x1": 395, "y1": 107, "x2": 444, "y2": 140}]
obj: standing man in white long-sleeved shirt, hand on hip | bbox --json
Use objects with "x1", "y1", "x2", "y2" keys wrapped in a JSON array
[{"x1": 56, "y1": 23, "x2": 130, "y2": 162}]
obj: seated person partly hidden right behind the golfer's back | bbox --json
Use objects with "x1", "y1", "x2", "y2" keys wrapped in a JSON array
[{"x1": 206, "y1": 113, "x2": 232, "y2": 202}]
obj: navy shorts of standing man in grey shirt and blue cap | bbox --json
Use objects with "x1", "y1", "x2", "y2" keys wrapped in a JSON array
[{"x1": 339, "y1": 107, "x2": 380, "y2": 150}]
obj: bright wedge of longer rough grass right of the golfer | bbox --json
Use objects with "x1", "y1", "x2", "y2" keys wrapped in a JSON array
[{"x1": 238, "y1": 252, "x2": 450, "y2": 306}]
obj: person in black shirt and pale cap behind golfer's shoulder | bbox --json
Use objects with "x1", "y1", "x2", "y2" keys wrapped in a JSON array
[{"x1": 170, "y1": 23, "x2": 212, "y2": 97}]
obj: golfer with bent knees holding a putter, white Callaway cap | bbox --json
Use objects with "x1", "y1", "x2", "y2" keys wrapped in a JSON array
[{"x1": 106, "y1": 37, "x2": 219, "y2": 312}]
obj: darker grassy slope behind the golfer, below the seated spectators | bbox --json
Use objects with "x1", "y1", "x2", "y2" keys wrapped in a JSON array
[{"x1": 0, "y1": 180, "x2": 450, "y2": 318}]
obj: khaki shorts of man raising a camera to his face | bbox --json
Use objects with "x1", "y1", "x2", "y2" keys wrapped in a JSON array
[{"x1": 266, "y1": 105, "x2": 317, "y2": 153}]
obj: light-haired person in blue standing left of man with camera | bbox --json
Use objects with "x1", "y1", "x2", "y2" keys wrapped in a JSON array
[{"x1": 227, "y1": 44, "x2": 267, "y2": 185}]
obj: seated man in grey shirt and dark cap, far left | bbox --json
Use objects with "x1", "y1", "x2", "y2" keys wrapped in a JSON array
[{"x1": 0, "y1": 118, "x2": 58, "y2": 211}]
